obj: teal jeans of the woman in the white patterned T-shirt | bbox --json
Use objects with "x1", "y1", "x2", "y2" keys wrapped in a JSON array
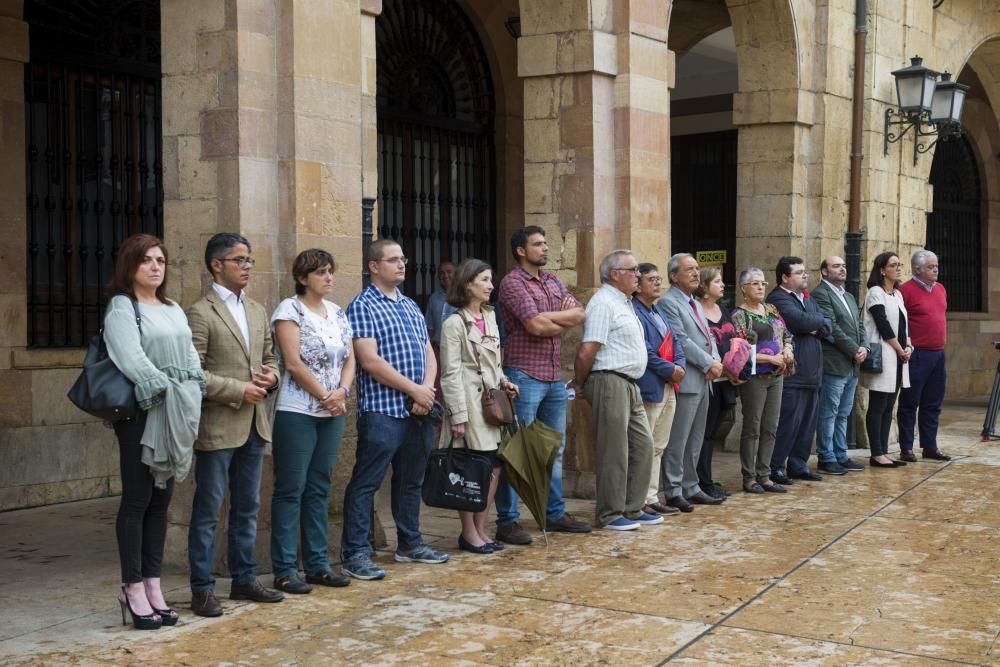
[{"x1": 271, "y1": 410, "x2": 344, "y2": 577}]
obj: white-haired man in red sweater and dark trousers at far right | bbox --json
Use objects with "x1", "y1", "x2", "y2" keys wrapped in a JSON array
[{"x1": 896, "y1": 250, "x2": 951, "y2": 461}]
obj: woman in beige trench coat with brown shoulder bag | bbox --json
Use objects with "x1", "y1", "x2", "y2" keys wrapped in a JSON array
[{"x1": 440, "y1": 259, "x2": 517, "y2": 554}]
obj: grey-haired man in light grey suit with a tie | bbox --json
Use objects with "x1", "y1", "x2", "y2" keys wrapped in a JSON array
[{"x1": 656, "y1": 253, "x2": 724, "y2": 512}]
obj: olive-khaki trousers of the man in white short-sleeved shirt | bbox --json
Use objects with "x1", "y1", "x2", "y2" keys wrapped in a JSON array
[{"x1": 583, "y1": 373, "x2": 653, "y2": 527}]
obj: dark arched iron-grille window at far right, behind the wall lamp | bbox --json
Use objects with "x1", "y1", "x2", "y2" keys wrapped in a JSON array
[{"x1": 927, "y1": 136, "x2": 984, "y2": 312}]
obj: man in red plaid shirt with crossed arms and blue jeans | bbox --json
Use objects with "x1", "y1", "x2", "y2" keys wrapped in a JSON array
[{"x1": 496, "y1": 226, "x2": 590, "y2": 544}]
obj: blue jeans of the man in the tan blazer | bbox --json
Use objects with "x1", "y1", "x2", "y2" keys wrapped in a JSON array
[{"x1": 188, "y1": 427, "x2": 264, "y2": 592}]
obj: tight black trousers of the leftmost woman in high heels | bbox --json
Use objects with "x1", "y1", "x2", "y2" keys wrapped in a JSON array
[{"x1": 115, "y1": 412, "x2": 174, "y2": 584}]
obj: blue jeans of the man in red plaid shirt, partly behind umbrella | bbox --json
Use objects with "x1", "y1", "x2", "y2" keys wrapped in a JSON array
[{"x1": 496, "y1": 368, "x2": 566, "y2": 528}]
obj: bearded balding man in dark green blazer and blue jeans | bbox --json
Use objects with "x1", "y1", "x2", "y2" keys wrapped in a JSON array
[{"x1": 810, "y1": 256, "x2": 868, "y2": 475}]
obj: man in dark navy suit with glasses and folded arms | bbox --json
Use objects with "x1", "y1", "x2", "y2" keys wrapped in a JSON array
[{"x1": 767, "y1": 256, "x2": 832, "y2": 484}]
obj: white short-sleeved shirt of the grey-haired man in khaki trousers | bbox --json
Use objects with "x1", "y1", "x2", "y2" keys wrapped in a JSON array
[{"x1": 581, "y1": 284, "x2": 647, "y2": 379}]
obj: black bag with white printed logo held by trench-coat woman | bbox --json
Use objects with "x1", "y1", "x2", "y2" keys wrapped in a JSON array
[{"x1": 420, "y1": 438, "x2": 493, "y2": 512}]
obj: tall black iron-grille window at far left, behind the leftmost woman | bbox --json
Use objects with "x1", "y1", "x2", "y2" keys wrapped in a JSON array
[{"x1": 25, "y1": 2, "x2": 163, "y2": 347}]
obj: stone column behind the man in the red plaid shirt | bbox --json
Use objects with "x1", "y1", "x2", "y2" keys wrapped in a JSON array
[{"x1": 518, "y1": 1, "x2": 674, "y2": 497}]
